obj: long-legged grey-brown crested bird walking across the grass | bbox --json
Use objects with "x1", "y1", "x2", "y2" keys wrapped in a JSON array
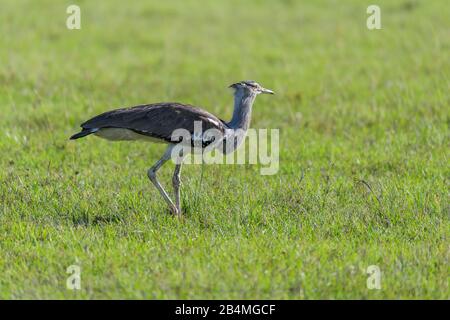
[{"x1": 70, "y1": 80, "x2": 274, "y2": 217}]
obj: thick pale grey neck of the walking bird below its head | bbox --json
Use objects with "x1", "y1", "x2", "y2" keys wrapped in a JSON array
[{"x1": 228, "y1": 91, "x2": 256, "y2": 131}]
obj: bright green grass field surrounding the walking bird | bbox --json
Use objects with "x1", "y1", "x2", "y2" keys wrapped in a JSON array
[{"x1": 0, "y1": 0, "x2": 450, "y2": 299}]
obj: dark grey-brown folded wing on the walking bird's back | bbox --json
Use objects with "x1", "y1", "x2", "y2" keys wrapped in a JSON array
[{"x1": 81, "y1": 102, "x2": 225, "y2": 141}]
